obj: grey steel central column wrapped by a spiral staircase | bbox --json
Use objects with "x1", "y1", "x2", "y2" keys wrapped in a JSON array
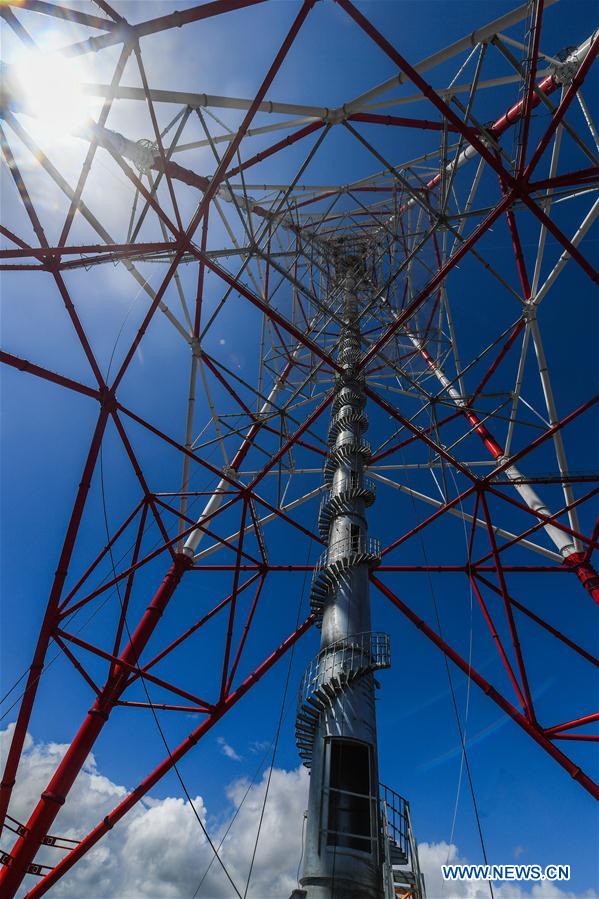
[{"x1": 295, "y1": 257, "x2": 389, "y2": 899}]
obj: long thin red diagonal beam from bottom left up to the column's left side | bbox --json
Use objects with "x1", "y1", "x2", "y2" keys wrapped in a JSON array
[{"x1": 23, "y1": 615, "x2": 314, "y2": 899}]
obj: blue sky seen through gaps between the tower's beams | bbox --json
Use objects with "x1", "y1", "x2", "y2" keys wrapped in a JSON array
[{"x1": 0, "y1": 0, "x2": 599, "y2": 899}]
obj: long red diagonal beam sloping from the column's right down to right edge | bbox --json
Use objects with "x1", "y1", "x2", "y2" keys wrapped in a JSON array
[{"x1": 370, "y1": 575, "x2": 599, "y2": 799}]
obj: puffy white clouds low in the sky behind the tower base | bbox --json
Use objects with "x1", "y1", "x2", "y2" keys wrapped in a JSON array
[{"x1": 0, "y1": 725, "x2": 599, "y2": 899}]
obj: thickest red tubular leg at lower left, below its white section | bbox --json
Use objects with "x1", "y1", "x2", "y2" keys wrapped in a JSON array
[{"x1": 0, "y1": 556, "x2": 190, "y2": 899}]
